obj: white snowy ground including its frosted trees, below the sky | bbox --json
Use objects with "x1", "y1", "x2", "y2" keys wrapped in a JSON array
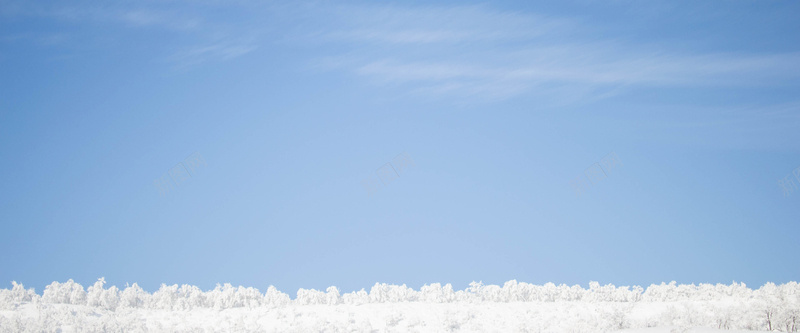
[{"x1": 0, "y1": 279, "x2": 800, "y2": 333}]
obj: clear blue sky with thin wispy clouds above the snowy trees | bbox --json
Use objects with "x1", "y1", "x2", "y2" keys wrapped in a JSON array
[{"x1": 0, "y1": 0, "x2": 800, "y2": 295}]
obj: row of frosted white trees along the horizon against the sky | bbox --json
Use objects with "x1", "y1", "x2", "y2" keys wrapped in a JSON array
[{"x1": 0, "y1": 278, "x2": 800, "y2": 310}]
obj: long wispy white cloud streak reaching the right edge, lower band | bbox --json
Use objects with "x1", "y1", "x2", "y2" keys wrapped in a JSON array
[{"x1": 346, "y1": 48, "x2": 800, "y2": 99}]
